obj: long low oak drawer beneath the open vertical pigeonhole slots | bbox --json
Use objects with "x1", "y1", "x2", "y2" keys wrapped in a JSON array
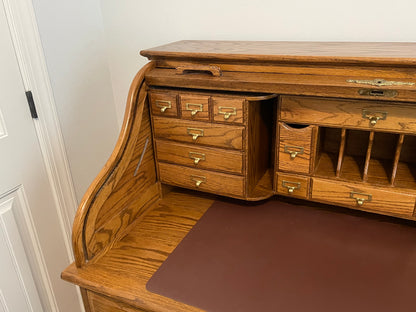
[{"x1": 312, "y1": 178, "x2": 416, "y2": 217}]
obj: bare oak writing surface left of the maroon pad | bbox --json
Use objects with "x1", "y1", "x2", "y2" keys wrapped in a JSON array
[{"x1": 62, "y1": 190, "x2": 214, "y2": 312}]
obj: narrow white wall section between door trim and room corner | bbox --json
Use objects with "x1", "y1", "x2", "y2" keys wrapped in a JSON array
[{"x1": 33, "y1": 0, "x2": 119, "y2": 201}]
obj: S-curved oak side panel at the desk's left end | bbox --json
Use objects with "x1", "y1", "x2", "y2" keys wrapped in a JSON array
[{"x1": 72, "y1": 62, "x2": 160, "y2": 267}]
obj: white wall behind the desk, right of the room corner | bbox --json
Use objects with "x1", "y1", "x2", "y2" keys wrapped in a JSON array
[{"x1": 101, "y1": 0, "x2": 416, "y2": 125}]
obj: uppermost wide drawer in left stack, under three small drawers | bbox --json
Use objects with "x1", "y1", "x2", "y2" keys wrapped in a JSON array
[{"x1": 153, "y1": 117, "x2": 244, "y2": 150}]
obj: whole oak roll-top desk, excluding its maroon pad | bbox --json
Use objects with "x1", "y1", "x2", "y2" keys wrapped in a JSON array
[{"x1": 62, "y1": 41, "x2": 416, "y2": 312}]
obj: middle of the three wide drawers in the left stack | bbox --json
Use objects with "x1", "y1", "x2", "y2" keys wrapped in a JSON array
[{"x1": 156, "y1": 140, "x2": 244, "y2": 174}]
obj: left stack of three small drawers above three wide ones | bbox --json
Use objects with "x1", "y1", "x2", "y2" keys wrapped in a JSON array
[{"x1": 149, "y1": 89, "x2": 252, "y2": 198}]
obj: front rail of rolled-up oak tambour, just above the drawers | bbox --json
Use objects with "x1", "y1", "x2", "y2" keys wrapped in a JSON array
[{"x1": 146, "y1": 68, "x2": 416, "y2": 102}]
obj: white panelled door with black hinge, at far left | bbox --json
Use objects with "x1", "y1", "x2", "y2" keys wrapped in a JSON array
[{"x1": 0, "y1": 4, "x2": 81, "y2": 312}]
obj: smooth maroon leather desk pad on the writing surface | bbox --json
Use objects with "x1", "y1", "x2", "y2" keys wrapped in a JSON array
[{"x1": 147, "y1": 200, "x2": 416, "y2": 312}]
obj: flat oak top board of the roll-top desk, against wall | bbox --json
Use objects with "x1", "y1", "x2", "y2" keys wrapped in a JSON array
[{"x1": 140, "y1": 40, "x2": 416, "y2": 66}]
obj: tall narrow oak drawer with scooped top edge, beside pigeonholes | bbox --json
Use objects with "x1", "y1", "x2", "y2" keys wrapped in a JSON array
[{"x1": 279, "y1": 122, "x2": 314, "y2": 173}]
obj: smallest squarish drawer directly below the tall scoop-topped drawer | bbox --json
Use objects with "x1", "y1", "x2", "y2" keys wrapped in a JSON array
[{"x1": 276, "y1": 172, "x2": 310, "y2": 199}]
